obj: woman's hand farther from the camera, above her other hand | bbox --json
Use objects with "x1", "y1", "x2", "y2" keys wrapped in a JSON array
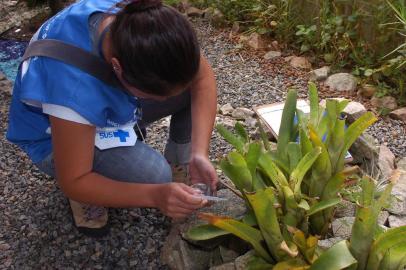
[{"x1": 189, "y1": 155, "x2": 218, "y2": 191}]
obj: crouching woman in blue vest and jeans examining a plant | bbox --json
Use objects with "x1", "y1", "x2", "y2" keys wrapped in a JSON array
[{"x1": 7, "y1": 0, "x2": 217, "y2": 235}]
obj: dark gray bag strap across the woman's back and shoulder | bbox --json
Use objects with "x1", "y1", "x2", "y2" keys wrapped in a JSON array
[{"x1": 22, "y1": 39, "x2": 124, "y2": 89}]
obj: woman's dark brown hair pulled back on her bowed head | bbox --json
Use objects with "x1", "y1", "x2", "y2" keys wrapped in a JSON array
[{"x1": 111, "y1": 0, "x2": 200, "y2": 96}]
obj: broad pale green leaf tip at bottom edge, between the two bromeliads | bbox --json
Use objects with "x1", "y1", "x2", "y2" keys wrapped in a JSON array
[{"x1": 310, "y1": 240, "x2": 357, "y2": 270}]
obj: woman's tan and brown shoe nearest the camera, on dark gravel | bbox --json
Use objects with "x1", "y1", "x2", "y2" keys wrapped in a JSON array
[{"x1": 69, "y1": 200, "x2": 110, "y2": 237}]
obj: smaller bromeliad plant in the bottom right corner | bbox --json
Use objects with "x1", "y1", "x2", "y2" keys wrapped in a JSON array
[{"x1": 350, "y1": 171, "x2": 406, "y2": 270}]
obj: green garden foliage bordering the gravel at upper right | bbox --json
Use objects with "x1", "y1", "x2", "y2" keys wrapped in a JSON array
[{"x1": 187, "y1": 0, "x2": 406, "y2": 104}]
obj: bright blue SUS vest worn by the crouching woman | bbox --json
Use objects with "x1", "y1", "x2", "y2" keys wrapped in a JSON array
[{"x1": 7, "y1": 0, "x2": 138, "y2": 162}]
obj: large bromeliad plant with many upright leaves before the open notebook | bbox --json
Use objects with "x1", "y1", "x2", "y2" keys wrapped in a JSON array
[{"x1": 186, "y1": 84, "x2": 376, "y2": 269}]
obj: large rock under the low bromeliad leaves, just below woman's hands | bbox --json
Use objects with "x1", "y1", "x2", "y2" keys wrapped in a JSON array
[{"x1": 161, "y1": 189, "x2": 247, "y2": 270}]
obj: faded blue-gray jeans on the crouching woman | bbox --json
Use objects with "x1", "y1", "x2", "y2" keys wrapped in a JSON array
[{"x1": 36, "y1": 91, "x2": 192, "y2": 183}]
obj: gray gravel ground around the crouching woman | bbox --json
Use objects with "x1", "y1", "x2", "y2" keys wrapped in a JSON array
[{"x1": 0, "y1": 17, "x2": 406, "y2": 269}]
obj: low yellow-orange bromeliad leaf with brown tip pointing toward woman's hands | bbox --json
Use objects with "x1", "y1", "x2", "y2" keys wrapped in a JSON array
[{"x1": 199, "y1": 213, "x2": 273, "y2": 263}]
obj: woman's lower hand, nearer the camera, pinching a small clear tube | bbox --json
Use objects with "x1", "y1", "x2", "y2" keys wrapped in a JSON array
[{"x1": 156, "y1": 183, "x2": 207, "y2": 219}]
